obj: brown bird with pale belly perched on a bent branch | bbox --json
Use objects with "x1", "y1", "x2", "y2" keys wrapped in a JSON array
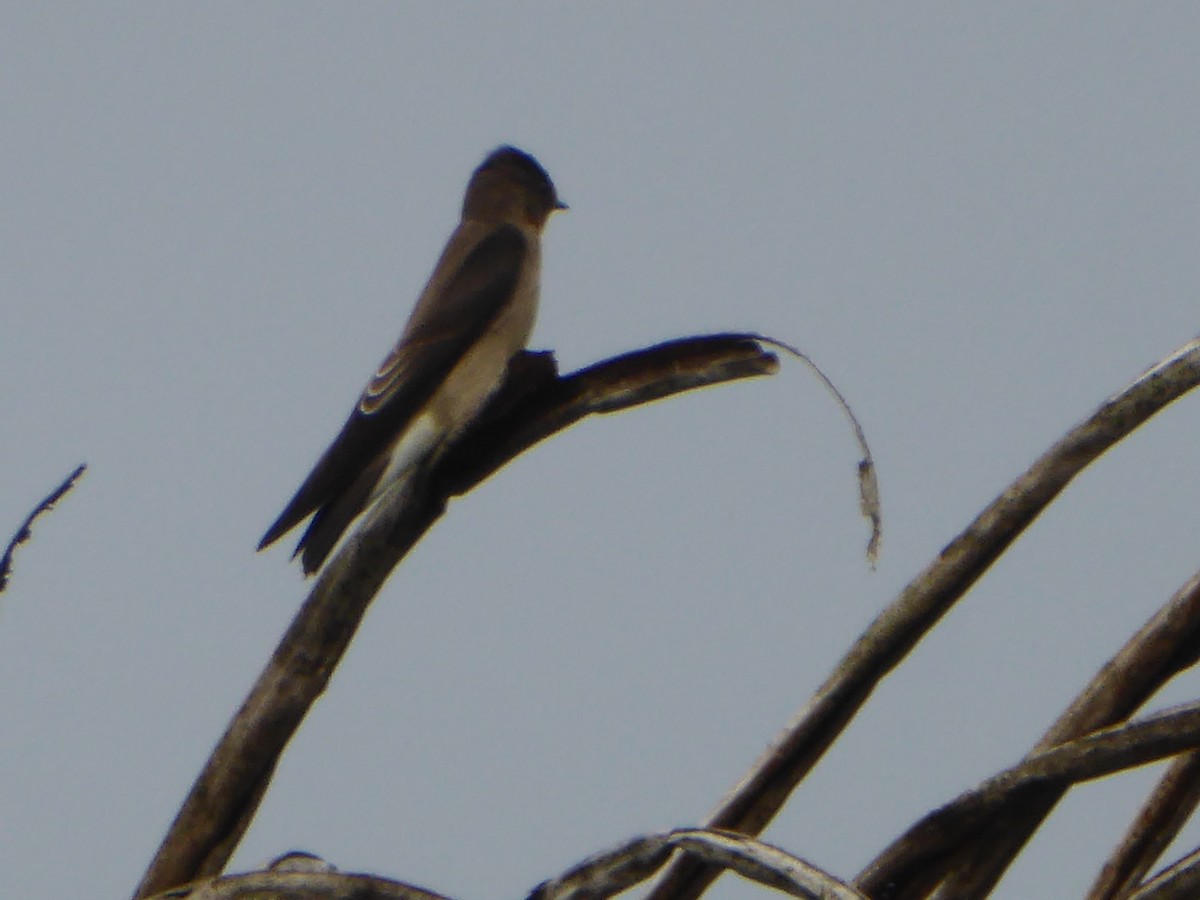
[{"x1": 258, "y1": 146, "x2": 566, "y2": 575}]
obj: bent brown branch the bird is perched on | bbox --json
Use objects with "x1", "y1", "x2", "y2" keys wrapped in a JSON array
[{"x1": 134, "y1": 335, "x2": 778, "y2": 898}]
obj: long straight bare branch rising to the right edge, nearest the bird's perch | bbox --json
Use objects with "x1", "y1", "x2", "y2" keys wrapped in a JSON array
[{"x1": 650, "y1": 341, "x2": 1200, "y2": 900}]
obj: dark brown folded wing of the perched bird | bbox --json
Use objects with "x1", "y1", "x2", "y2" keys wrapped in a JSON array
[{"x1": 258, "y1": 224, "x2": 527, "y2": 550}]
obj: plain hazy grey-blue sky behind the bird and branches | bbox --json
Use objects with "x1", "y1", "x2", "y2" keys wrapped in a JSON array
[{"x1": 0, "y1": 2, "x2": 1200, "y2": 900}]
